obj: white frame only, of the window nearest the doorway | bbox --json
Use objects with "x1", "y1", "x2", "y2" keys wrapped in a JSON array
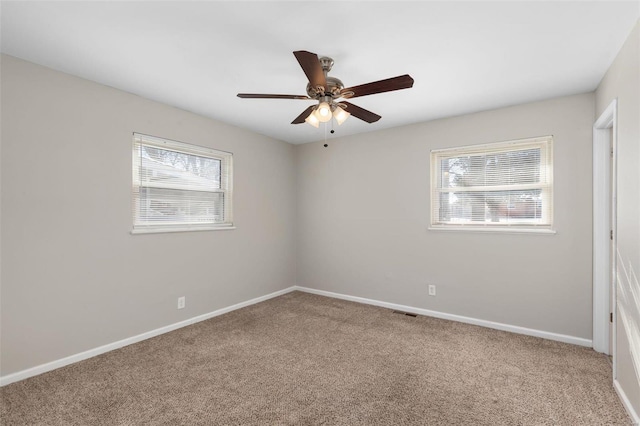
[{"x1": 428, "y1": 135, "x2": 556, "y2": 234}]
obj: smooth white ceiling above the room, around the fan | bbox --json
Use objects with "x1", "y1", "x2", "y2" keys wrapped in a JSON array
[{"x1": 0, "y1": 1, "x2": 640, "y2": 144}]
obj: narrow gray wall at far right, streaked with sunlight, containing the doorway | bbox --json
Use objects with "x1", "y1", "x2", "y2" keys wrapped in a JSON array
[{"x1": 596, "y1": 21, "x2": 640, "y2": 415}]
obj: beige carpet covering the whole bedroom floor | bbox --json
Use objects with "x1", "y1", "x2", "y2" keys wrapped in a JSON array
[{"x1": 0, "y1": 292, "x2": 631, "y2": 425}]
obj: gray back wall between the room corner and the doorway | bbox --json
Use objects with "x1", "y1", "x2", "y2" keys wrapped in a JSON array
[{"x1": 296, "y1": 94, "x2": 594, "y2": 339}]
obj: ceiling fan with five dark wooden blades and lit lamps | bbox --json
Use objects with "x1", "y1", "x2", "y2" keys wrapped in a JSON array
[{"x1": 238, "y1": 50, "x2": 413, "y2": 127}]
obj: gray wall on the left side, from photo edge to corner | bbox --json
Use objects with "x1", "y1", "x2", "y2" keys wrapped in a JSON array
[{"x1": 0, "y1": 56, "x2": 295, "y2": 375}]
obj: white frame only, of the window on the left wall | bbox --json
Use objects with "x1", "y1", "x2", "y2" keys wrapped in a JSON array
[{"x1": 131, "y1": 133, "x2": 235, "y2": 234}]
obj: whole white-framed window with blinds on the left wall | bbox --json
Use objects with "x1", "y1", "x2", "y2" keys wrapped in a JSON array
[{"x1": 132, "y1": 133, "x2": 233, "y2": 233}]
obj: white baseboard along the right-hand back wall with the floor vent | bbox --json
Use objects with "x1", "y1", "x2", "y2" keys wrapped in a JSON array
[{"x1": 293, "y1": 286, "x2": 593, "y2": 348}]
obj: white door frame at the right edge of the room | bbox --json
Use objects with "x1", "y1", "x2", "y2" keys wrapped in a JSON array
[{"x1": 593, "y1": 99, "x2": 618, "y2": 366}]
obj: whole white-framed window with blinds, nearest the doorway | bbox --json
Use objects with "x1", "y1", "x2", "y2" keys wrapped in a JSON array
[{"x1": 431, "y1": 136, "x2": 553, "y2": 232}]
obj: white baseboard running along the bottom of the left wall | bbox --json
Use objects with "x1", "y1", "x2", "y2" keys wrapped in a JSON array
[{"x1": 0, "y1": 287, "x2": 295, "y2": 387}]
